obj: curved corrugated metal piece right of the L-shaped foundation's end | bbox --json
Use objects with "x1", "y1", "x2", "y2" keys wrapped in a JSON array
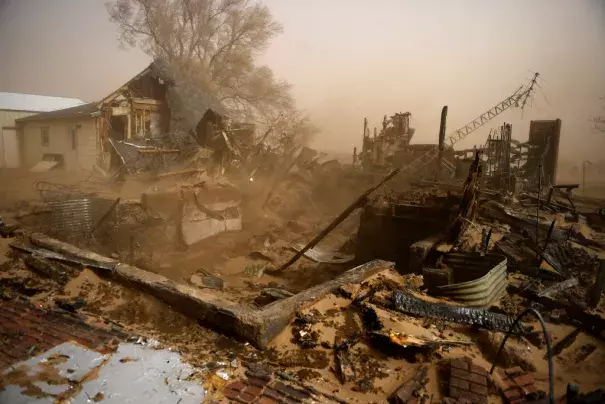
[{"x1": 437, "y1": 253, "x2": 507, "y2": 307}]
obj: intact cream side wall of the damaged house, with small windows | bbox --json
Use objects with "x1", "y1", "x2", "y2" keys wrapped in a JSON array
[{"x1": 22, "y1": 117, "x2": 97, "y2": 171}]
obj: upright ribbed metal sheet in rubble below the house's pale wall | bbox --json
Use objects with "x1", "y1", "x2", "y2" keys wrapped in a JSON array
[{"x1": 48, "y1": 198, "x2": 114, "y2": 240}]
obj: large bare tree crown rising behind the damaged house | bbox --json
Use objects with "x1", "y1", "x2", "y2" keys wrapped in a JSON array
[{"x1": 107, "y1": 0, "x2": 295, "y2": 123}]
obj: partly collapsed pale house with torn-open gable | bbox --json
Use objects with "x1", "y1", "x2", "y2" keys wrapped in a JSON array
[{"x1": 16, "y1": 61, "x2": 231, "y2": 171}]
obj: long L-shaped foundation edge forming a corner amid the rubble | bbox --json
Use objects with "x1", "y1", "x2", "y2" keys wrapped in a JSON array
[{"x1": 20, "y1": 234, "x2": 394, "y2": 349}]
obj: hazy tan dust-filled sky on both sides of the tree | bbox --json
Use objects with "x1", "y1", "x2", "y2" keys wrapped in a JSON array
[{"x1": 0, "y1": 0, "x2": 605, "y2": 160}]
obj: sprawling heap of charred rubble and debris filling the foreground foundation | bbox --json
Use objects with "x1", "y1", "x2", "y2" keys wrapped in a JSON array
[{"x1": 0, "y1": 134, "x2": 605, "y2": 403}]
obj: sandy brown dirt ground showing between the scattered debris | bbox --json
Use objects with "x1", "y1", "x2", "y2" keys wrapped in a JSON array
[{"x1": 0, "y1": 166, "x2": 605, "y2": 403}]
